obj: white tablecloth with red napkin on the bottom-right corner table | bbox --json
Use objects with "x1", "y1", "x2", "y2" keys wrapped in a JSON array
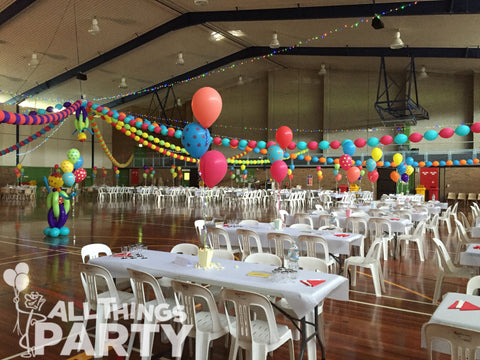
[{"x1": 422, "y1": 293, "x2": 480, "y2": 359}]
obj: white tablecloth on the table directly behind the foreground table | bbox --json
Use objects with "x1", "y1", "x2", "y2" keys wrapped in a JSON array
[{"x1": 224, "y1": 223, "x2": 362, "y2": 255}]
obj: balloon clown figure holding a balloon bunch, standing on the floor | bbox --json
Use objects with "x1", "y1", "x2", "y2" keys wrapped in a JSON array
[{"x1": 43, "y1": 149, "x2": 87, "y2": 237}]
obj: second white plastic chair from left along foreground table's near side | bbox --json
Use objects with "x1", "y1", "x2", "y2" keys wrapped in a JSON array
[{"x1": 126, "y1": 269, "x2": 176, "y2": 360}]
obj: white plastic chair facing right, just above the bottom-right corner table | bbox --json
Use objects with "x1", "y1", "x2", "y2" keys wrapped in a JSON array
[{"x1": 433, "y1": 238, "x2": 475, "y2": 304}]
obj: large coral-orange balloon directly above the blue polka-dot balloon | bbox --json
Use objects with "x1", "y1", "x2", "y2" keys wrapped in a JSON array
[{"x1": 192, "y1": 87, "x2": 222, "y2": 129}]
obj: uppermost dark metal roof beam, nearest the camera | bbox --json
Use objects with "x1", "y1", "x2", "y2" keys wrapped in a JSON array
[{"x1": 7, "y1": 0, "x2": 480, "y2": 104}]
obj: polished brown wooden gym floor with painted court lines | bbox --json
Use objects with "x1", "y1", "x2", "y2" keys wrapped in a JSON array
[{"x1": 0, "y1": 197, "x2": 466, "y2": 360}]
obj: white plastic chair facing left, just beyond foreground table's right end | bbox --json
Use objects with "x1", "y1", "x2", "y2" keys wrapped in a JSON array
[{"x1": 343, "y1": 238, "x2": 385, "y2": 297}]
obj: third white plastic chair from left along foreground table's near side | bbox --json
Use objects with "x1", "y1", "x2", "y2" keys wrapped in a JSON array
[{"x1": 172, "y1": 281, "x2": 229, "y2": 360}]
